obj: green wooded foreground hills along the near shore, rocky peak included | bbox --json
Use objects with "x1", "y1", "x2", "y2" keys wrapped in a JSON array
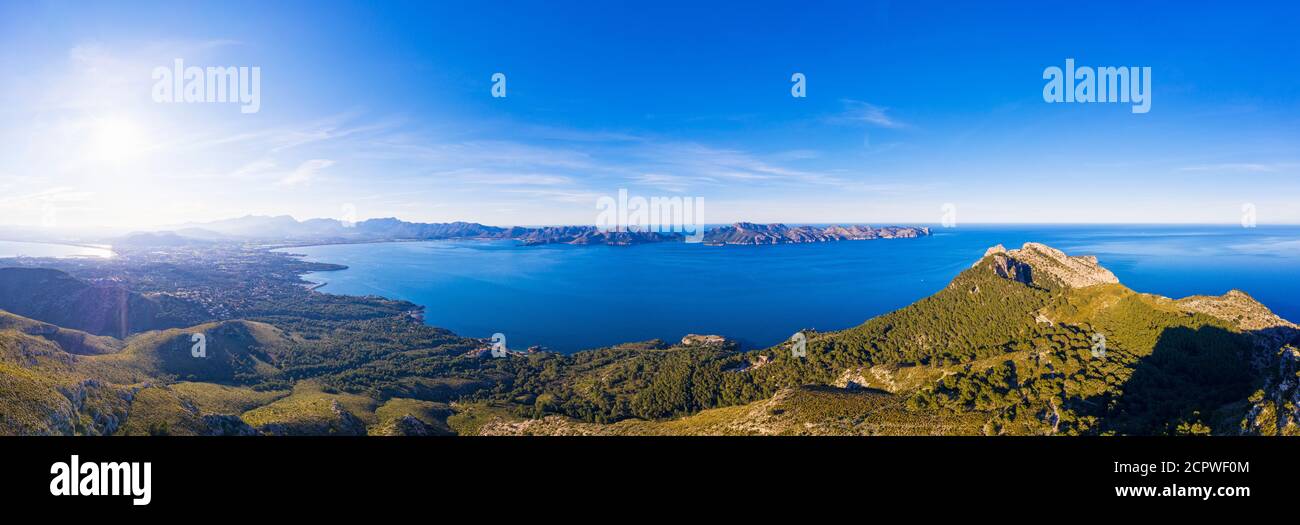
[{"x1": 0, "y1": 243, "x2": 1300, "y2": 435}]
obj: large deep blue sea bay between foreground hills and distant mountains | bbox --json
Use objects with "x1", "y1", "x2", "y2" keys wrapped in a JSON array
[{"x1": 279, "y1": 225, "x2": 1300, "y2": 351}]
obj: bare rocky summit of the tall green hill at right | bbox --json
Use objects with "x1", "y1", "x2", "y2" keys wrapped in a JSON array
[{"x1": 976, "y1": 243, "x2": 1119, "y2": 288}]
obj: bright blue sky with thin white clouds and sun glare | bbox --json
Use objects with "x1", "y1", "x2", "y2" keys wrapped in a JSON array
[{"x1": 0, "y1": 1, "x2": 1300, "y2": 227}]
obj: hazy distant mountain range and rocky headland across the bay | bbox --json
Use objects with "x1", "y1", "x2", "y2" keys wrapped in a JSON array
[{"x1": 113, "y1": 216, "x2": 930, "y2": 250}]
